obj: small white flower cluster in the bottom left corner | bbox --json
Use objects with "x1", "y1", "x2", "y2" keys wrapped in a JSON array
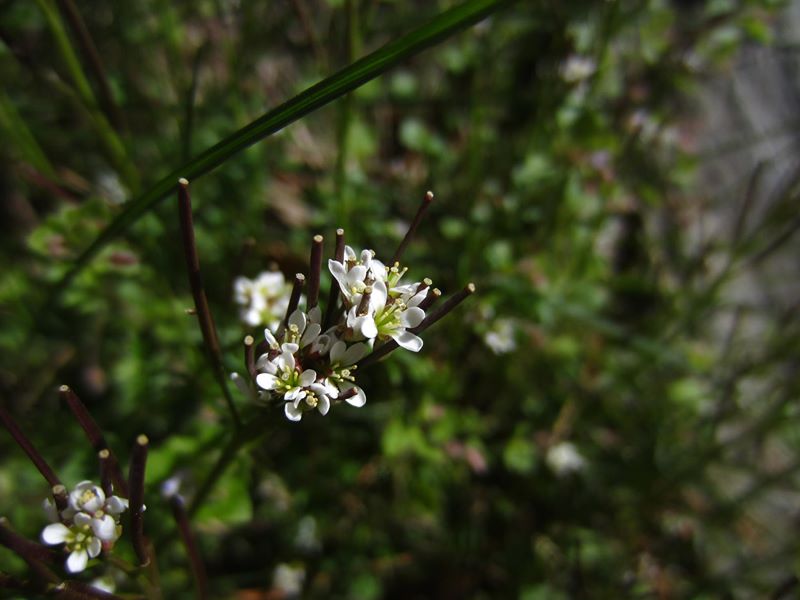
[{"x1": 42, "y1": 481, "x2": 128, "y2": 573}]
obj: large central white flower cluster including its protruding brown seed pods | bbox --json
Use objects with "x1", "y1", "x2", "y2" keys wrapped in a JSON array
[{"x1": 238, "y1": 192, "x2": 475, "y2": 421}]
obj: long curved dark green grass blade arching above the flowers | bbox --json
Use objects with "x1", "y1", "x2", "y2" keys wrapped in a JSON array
[{"x1": 53, "y1": 0, "x2": 514, "y2": 298}]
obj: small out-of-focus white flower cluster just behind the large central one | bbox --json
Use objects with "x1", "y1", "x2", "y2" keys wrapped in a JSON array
[{"x1": 233, "y1": 271, "x2": 292, "y2": 328}]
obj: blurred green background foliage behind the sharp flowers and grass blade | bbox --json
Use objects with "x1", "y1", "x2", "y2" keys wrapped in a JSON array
[{"x1": 0, "y1": 0, "x2": 800, "y2": 600}]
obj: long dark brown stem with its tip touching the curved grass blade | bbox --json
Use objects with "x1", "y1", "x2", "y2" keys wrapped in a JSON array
[{"x1": 178, "y1": 179, "x2": 241, "y2": 430}]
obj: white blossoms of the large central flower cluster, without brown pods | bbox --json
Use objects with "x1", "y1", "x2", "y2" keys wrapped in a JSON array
[{"x1": 255, "y1": 241, "x2": 430, "y2": 421}]
